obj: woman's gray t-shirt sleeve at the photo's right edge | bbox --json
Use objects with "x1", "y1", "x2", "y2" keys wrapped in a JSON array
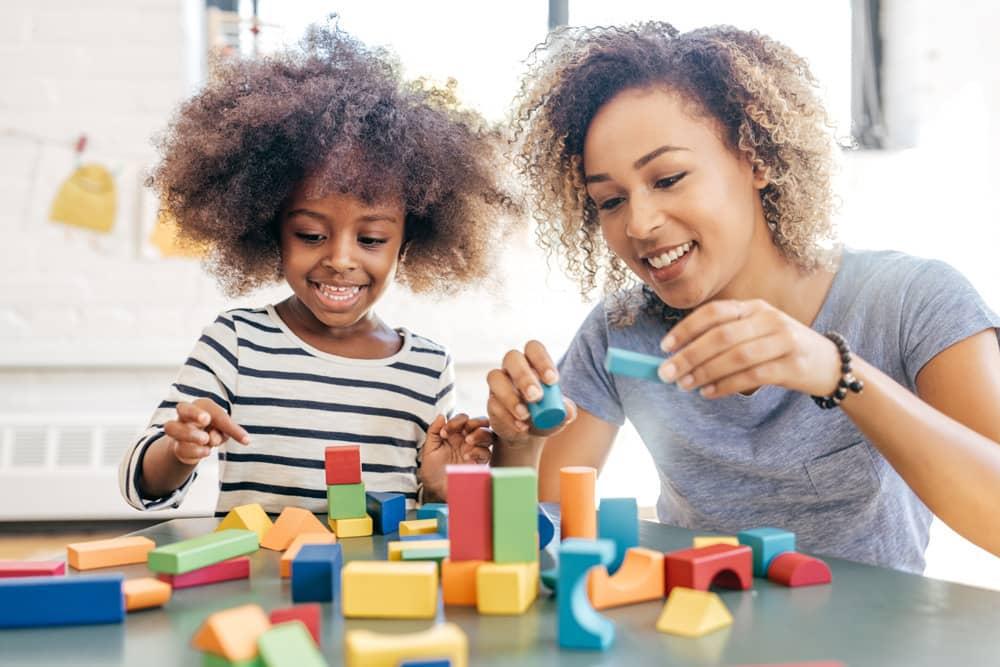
[{"x1": 900, "y1": 260, "x2": 1000, "y2": 386}]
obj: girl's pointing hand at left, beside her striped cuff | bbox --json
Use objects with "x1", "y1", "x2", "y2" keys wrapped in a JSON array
[{"x1": 163, "y1": 398, "x2": 250, "y2": 465}]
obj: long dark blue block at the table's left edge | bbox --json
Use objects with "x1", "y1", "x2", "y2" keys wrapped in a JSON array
[{"x1": 0, "y1": 574, "x2": 125, "y2": 628}]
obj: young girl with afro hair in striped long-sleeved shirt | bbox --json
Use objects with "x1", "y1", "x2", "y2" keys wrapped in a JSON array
[{"x1": 120, "y1": 23, "x2": 511, "y2": 513}]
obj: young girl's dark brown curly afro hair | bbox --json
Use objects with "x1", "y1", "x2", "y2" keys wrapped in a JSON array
[{"x1": 154, "y1": 21, "x2": 517, "y2": 295}]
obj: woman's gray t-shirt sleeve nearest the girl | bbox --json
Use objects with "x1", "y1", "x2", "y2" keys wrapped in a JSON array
[{"x1": 558, "y1": 304, "x2": 625, "y2": 426}]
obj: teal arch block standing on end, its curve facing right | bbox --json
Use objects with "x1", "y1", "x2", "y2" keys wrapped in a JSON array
[{"x1": 556, "y1": 538, "x2": 615, "y2": 651}]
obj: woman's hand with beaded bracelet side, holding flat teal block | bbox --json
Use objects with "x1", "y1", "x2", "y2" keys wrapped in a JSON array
[{"x1": 659, "y1": 299, "x2": 840, "y2": 398}]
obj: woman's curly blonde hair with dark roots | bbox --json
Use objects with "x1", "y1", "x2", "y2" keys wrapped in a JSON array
[{"x1": 512, "y1": 22, "x2": 834, "y2": 322}]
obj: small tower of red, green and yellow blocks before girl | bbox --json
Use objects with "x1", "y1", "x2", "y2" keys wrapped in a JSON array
[{"x1": 324, "y1": 445, "x2": 372, "y2": 537}]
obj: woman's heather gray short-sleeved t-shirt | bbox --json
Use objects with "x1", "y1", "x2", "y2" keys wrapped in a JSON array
[{"x1": 559, "y1": 250, "x2": 1000, "y2": 572}]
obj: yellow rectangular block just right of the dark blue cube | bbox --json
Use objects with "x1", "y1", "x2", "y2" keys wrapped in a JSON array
[{"x1": 342, "y1": 560, "x2": 438, "y2": 618}]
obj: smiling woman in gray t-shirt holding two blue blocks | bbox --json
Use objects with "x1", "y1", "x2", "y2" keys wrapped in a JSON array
[{"x1": 488, "y1": 23, "x2": 1000, "y2": 571}]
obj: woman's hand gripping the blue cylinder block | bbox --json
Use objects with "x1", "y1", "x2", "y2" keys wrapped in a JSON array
[{"x1": 486, "y1": 340, "x2": 576, "y2": 444}]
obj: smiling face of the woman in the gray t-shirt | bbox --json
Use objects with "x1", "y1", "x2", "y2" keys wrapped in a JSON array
[{"x1": 583, "y1": 88, "x2": 776, "y2": 310}]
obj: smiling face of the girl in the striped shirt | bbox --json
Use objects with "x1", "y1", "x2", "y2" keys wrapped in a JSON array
[{"x1": 281, "y1": 184, "x2": 405, "y2": 334}]
